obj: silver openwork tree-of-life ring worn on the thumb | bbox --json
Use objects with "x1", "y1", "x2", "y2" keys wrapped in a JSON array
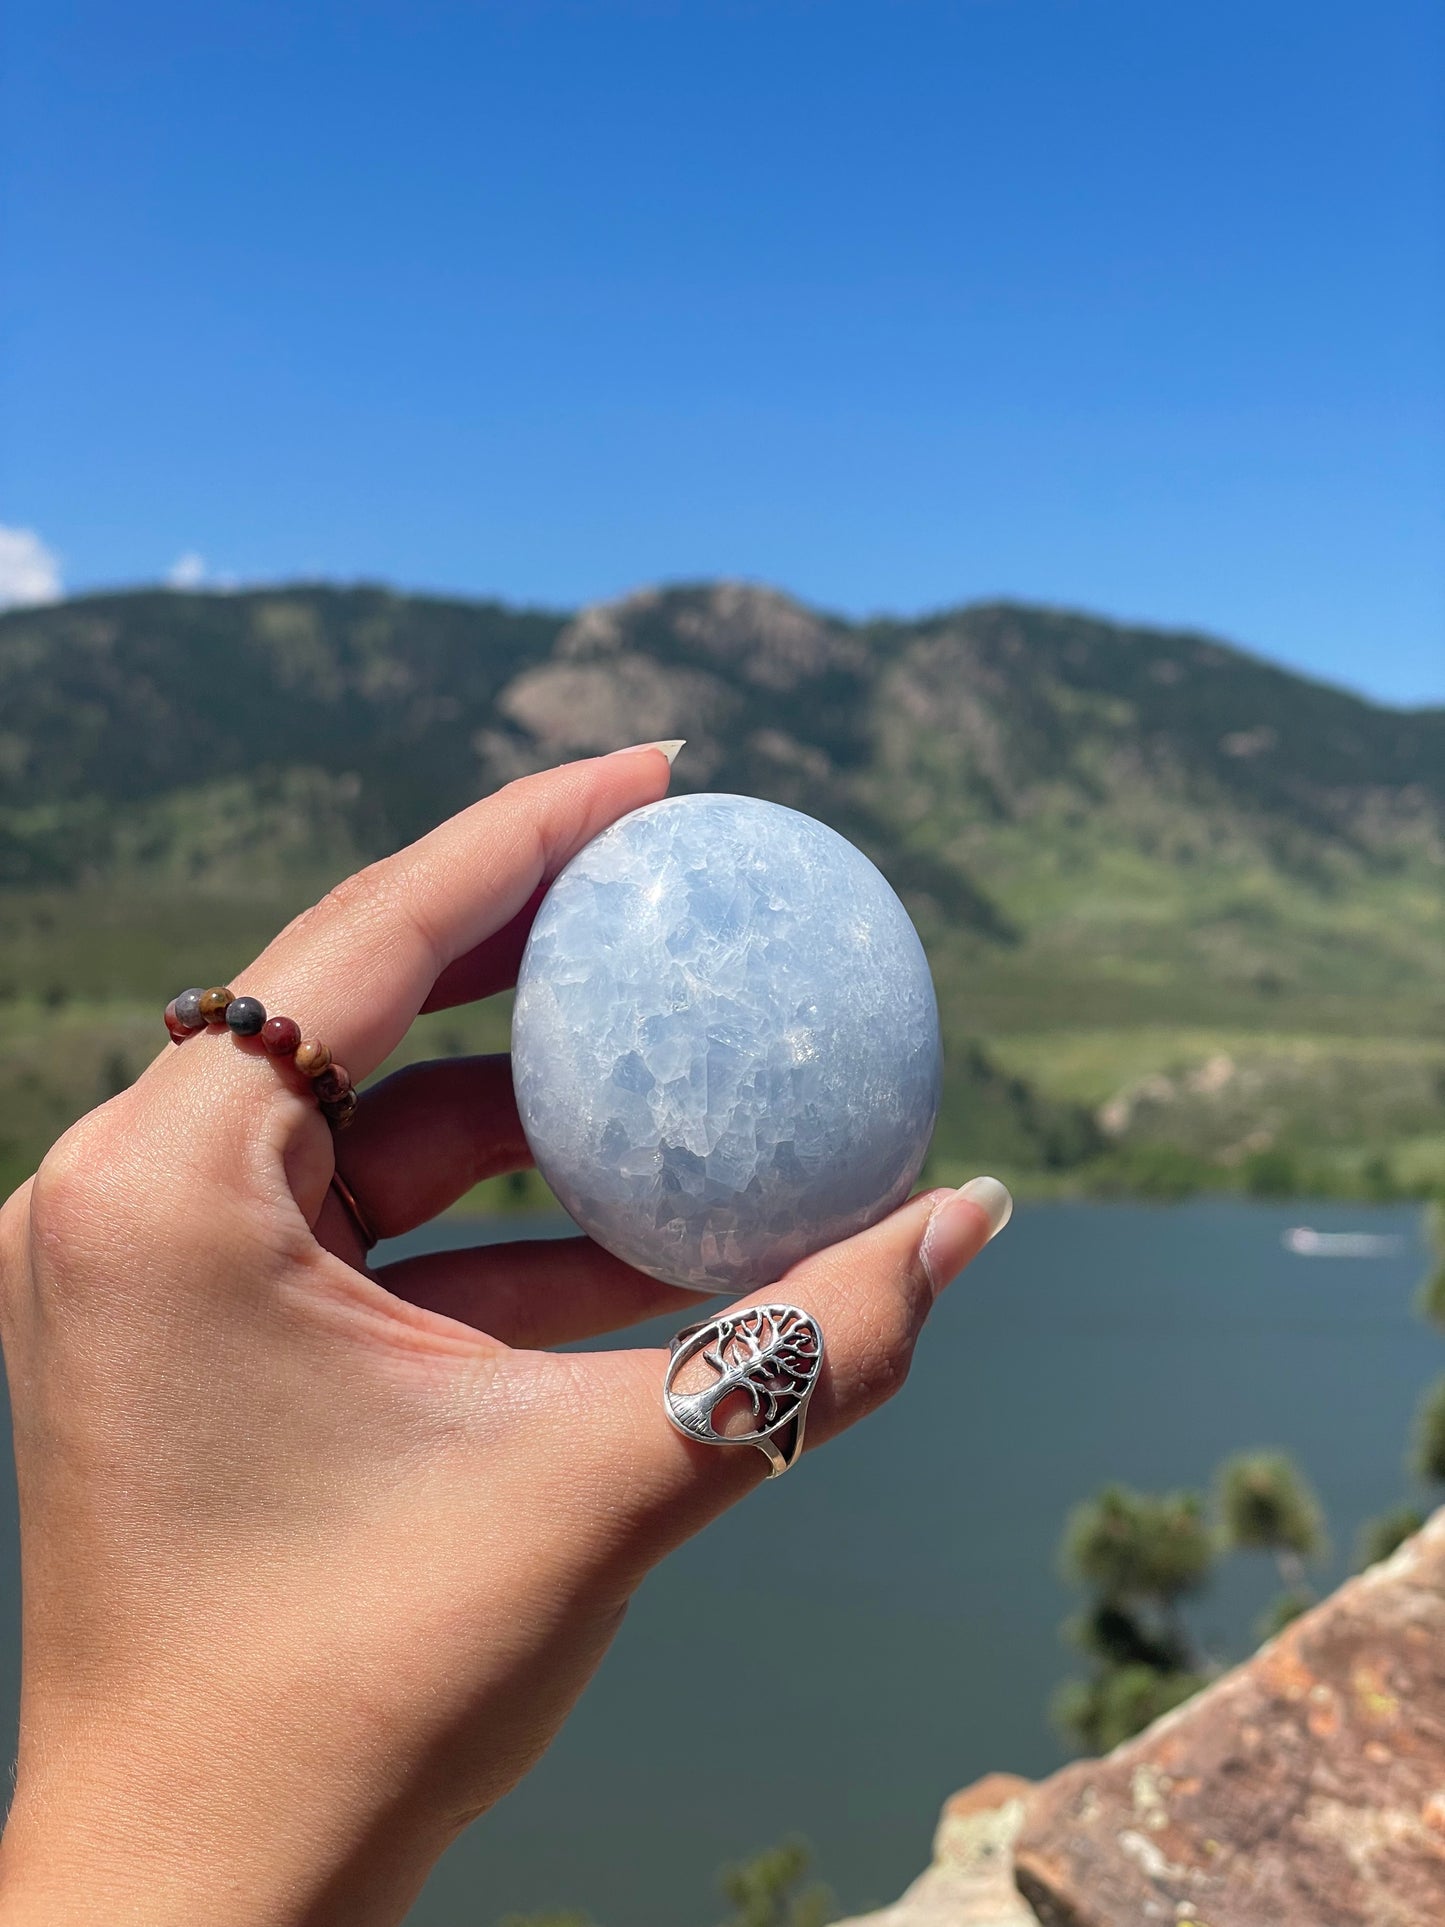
[{"x1": 663, "y1": 1305, "x2": 823, "y2": 1478}]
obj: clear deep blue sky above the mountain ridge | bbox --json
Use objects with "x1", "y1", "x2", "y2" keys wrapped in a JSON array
[{"x1": 0, "y1": 0, "x2": 1445, "y2": 700}]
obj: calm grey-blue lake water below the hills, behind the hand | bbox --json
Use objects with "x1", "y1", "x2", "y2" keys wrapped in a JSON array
[{"x1": 0, "y1": 1202, "x2": 1445, "y2": 1927}]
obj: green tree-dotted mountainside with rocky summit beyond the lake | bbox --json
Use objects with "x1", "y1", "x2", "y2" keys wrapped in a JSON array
[{"x1": 0, "y1": 584, "x2": 1445, "y2": 1195}]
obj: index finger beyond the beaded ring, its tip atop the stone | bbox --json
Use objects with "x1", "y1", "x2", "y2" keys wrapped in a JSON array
[{"x1": 233, "y1": 744, "x2": 672, "y2": 1081}]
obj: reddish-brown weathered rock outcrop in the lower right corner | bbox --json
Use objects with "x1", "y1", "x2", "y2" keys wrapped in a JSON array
[{"x1": 854, "y1": 1509, "x2": 1445, "y2": 1927}]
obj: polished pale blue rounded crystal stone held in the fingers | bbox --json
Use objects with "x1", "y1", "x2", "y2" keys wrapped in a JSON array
[{"x1": 512, "y1": 796, "x2": 942, "y2": 1291}]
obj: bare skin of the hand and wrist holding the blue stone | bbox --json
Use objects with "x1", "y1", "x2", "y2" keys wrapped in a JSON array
[{"x1": 0, "y1": 746, "x2": 1006, "y2": 1927}]
